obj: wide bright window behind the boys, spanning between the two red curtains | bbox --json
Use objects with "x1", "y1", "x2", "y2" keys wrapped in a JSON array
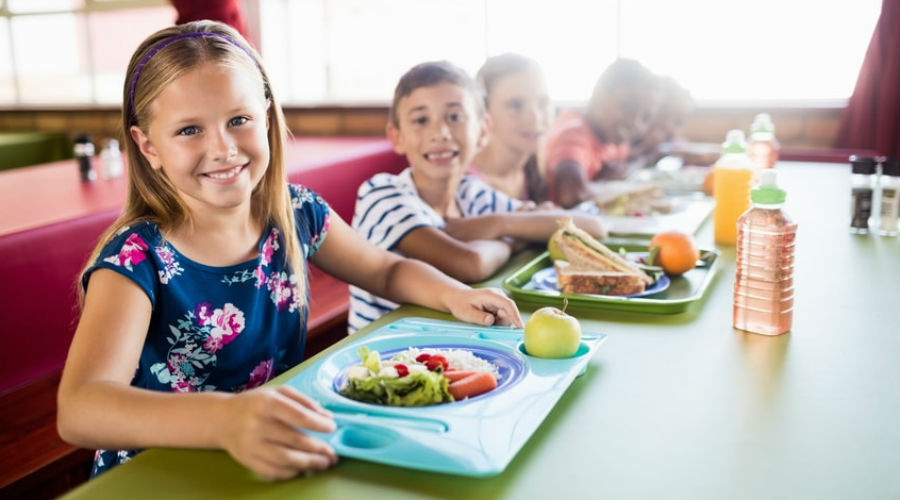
[{"x1": 259, "y1": 0, "x2": 881, "y2": 103}]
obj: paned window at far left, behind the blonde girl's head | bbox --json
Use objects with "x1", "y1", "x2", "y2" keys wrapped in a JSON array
[{"x1": 0, "y1": 0, "x2": 175, "y2": 105}]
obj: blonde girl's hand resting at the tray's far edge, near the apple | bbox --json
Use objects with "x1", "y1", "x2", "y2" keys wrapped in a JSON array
[{"x1": 447, "y1": 288, "x2": 524, "y2": 328}]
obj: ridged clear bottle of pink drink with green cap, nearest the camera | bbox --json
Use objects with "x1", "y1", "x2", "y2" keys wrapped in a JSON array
[{"x1": 733, "y1": 170, "x2": 797, "y2": 335}]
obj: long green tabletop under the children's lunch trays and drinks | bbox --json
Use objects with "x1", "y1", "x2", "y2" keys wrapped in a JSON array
[{"x1": 59, "y1": 163, "x2": 900, "y2": 500}]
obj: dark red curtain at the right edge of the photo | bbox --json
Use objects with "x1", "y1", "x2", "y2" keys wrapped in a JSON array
[{"x1": 835, "y1": 0, "x2": 900, "y2": 158}]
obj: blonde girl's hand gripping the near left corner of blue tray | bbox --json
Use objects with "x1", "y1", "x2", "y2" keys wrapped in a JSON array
[{"x1": 218, "y1": 386, "x2": 337, "y2": 479}]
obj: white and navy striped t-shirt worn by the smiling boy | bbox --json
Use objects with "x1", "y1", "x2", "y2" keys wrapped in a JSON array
[{"x1": 347, "y1": 168, "x2": 522, "y2": 333}]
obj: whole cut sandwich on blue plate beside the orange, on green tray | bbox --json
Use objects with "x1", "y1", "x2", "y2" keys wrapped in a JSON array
[{"x1": 552, "y1": 217, "x2": 654, "y2": 295}]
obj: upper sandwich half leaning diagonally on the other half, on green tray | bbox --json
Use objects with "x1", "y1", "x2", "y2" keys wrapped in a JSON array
[{"x1": 553, "y1": 217, "x2": 653, "y2": 286}]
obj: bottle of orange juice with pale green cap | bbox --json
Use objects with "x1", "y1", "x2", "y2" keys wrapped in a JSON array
[{"x1": 713, "y1": 130, "x2": 754, "y2": 245}]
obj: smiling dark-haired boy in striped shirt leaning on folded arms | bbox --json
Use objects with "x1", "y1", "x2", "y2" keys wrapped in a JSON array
[{"x1": 348, "y1": 61, "x2": 605, "y2": 333}]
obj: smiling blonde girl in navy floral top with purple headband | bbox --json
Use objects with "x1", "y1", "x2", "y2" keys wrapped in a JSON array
[{"x1": 58, "y1": 21, "x2": 521, "y2": 478}]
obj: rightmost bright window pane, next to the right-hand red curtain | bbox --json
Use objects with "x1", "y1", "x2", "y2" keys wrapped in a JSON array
[{"x1": 621, "y1": 0, "x2": 881, "y2": 101}]
